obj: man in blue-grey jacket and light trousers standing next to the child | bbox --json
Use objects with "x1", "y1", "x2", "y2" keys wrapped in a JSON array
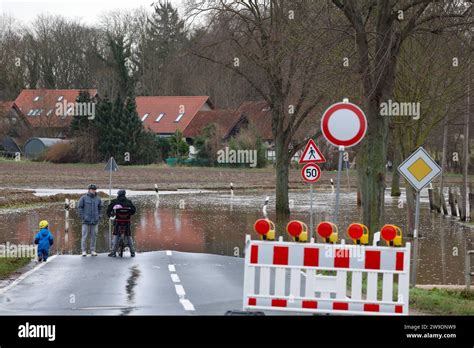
[{"x1": 78, "y1": 184, "x2": 103, "y2": 256}]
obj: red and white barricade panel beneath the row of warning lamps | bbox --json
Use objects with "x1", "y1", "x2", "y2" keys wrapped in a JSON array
[{"x1": 243, "y1": 237, "x2": 410, "y2": 315}]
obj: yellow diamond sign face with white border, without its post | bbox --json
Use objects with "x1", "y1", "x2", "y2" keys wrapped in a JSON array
[{"x1": 398, "y1": 147, "x2": 441, "y2": 191}]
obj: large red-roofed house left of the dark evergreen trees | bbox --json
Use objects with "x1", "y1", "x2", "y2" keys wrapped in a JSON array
[{"x1": 15, "y1": 89, "x2": 97, "y2": 137}]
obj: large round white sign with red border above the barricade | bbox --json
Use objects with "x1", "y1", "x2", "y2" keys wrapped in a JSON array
[{"x1": 321, "y1": 102, "x2": 367, "y2": 147}]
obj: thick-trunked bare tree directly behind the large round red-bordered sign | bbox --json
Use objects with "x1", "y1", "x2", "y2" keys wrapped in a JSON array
[{"x1": 332, "y1": 0, "x2": 473, "y2": 231}]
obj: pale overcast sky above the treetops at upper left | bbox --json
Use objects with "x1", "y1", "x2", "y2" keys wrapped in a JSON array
[{"x1": 0, "y1": 0, "x2": 183, "y2": 24}]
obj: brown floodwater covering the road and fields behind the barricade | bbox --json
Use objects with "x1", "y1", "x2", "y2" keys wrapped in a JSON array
[{"x1": 0, "y1": 190, "x2": 474, "y2": 284}]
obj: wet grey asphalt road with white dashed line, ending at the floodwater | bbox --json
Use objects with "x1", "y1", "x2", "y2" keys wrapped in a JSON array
[{"x1": 0, "y1": 251, "x2": 244, "y2": 315}]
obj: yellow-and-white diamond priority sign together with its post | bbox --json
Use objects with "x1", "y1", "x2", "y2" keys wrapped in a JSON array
[{"x1": 398, "y1": 147, "x2": 441, "y2": 286}]
